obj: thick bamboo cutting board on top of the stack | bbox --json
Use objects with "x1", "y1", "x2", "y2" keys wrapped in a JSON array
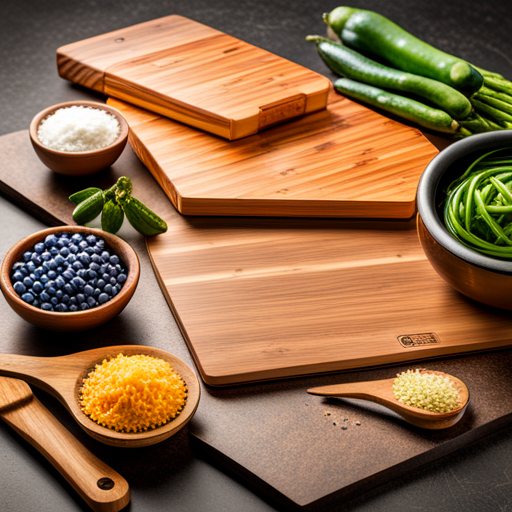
[{"x1": 57, "y1": 16, "x2": 329, "y2": 140}]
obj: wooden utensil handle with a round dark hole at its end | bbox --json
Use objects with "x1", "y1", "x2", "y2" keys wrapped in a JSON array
[{"x1": 0, "y1": 377, "x2": 130, "y2": 512}]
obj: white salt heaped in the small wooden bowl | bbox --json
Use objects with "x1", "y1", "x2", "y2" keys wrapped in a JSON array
[{"x1": 37, "y1": 105, "x2": 121, "y2": 153}]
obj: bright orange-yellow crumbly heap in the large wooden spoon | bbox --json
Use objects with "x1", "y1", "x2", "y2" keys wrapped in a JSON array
[{"x1": 80, "y1": 354, "x2": 187, "y2": 432}]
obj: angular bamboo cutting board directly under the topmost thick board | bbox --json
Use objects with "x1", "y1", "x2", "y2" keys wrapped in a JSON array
[{"x1": 109, "y1": 92, "x2": 438, "y2": 219}]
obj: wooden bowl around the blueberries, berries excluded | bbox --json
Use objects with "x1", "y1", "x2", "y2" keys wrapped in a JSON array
[{"x1": 0, "y1": 226, "x2": 140, "y2": 331}]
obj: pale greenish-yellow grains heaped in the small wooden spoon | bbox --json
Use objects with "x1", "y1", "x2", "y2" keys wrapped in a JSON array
[{"x1": 393, "y1": 370, "x2": 460, "y2": 413}]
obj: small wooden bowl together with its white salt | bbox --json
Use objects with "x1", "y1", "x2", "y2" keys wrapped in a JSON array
[{"x1": 29, "y1": 101, "x2": 129, "y2": 176}]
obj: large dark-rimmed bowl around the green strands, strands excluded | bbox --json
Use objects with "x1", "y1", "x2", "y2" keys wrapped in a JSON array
[{"x1": 417, "y1": 130, "x2": 512, "y2": 310}]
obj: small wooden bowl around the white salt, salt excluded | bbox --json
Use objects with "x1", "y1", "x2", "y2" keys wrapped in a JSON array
[{"x1": 29, "y1": 101, "x2": 129, "y2": 176}]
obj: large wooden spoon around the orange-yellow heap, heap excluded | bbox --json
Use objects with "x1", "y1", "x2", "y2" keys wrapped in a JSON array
[{"x1": 0, "y1": 345, "x2": 200, "y2": 447}]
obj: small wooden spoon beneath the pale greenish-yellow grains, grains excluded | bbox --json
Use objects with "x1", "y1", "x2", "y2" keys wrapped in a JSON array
[{"x1": 308, "y1": 370, "x2": 469, "y2": 430}]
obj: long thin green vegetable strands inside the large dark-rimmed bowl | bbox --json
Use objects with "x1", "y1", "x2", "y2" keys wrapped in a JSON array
[{"x1": 444, "y1": 147, "x2": 512, "y2": 260}]
